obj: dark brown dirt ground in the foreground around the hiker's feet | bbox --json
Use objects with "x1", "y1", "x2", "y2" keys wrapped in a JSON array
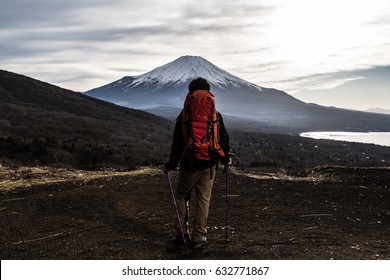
[{"x1": 0, "y1": 167, "x2": 390, "y2": 260}]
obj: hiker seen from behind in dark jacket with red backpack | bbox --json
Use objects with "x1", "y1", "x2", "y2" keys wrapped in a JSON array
[{"x1": 165, "y1": 78, "x2": 231, "y2": 249}]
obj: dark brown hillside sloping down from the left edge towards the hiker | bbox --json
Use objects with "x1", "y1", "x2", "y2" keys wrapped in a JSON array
[{"x1": 0, "y1": 70, "x2": 173, "y2": 168}]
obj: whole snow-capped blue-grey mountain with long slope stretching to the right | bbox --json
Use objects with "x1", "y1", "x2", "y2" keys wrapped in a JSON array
[{"x1": 85, "y1": 56, "x2": 390, "y2": 131}]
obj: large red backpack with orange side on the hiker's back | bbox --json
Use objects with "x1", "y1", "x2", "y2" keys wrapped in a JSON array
[{"x1": 182, "y1": 90, "x2": 225, "y2": 160}]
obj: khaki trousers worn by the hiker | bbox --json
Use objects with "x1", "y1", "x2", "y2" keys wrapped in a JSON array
[{"x1": 176, "y1": 167, "x2": 216, "y2": 242}]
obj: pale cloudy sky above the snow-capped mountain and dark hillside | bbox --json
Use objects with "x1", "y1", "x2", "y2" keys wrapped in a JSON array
[{"x1": 0, "y1": 0, "x2": 390, "y2": 110}]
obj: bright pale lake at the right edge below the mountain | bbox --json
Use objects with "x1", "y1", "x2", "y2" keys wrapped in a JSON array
[{"x1": 300, "y1": 131, "x2": 390, "y2": 146}]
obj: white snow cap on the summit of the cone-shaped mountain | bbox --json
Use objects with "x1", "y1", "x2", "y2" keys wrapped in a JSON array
[{"x1": 129, "y1": 56, "x2": 260, "y2": 89}]
